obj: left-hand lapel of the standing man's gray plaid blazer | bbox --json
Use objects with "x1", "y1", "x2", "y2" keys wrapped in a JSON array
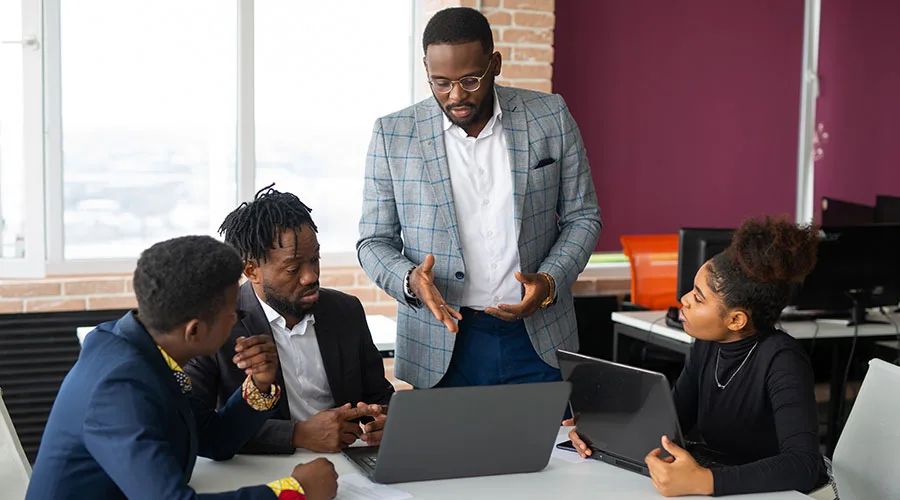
[{"x1": 415, "y1": 99, "x2": 462, "y2": 254}]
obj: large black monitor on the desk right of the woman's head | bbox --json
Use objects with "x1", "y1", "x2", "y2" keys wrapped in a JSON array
[{"x1": 791, "y1": 224, "x2": 900, "y2": 324}]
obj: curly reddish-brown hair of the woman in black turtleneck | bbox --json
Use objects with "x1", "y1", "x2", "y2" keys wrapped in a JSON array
[{"x1": 707, "y1": 216, "x2": 819, "y2": 331}]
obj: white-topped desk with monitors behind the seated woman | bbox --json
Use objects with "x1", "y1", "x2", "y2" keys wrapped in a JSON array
[{"x1": 612, "y1": 311, "x2": 900, "y2": 457}]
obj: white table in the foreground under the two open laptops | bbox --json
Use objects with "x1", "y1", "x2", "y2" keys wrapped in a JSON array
[{"x1": 191, "y1": 427, "x2": 809, "y2": 500}]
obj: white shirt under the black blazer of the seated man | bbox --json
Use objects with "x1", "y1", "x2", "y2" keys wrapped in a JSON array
[{"x1": 256, "y1": 295, "x2": 334, "y2": 422}]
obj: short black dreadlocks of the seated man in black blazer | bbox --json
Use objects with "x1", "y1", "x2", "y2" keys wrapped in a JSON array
[{"x1": 219, "y1": 184, "x2": 319, "y2": 265}]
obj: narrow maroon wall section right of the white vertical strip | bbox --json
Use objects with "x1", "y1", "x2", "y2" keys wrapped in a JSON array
[{"x1": 815, "y1": 0, "x2": 900, "y2": 215}]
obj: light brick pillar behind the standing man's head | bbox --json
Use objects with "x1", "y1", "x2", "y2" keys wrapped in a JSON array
[{"x1": 422, "y1": 0, "x2": 556, "y2": 92}]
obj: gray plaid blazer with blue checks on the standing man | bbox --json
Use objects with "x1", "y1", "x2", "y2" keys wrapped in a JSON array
[{"x1": 356, "y1": 86, "x2": 601, "y2": 388}]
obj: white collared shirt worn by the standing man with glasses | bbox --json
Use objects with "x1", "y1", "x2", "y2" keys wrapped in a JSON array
[{"x1": 444, "y1": 90, "x2": 522, "y2": 309}]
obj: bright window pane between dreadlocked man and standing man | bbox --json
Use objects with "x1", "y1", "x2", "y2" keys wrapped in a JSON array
[{"x1": 255, "y1": 0, "x2": 419, "y2": 252}]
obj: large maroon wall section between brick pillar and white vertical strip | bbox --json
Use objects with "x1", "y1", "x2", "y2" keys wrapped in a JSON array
[{"x1": 553, "y1": 0, "x2": 804, "y2": 250}]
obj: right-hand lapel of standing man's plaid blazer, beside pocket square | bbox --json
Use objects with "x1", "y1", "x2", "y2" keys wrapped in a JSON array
[{"x1": 496, "y1": 85, "x2": 530, "y2": 239}]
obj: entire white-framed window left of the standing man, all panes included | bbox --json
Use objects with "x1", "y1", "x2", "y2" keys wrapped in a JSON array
[{"x1": 0, "y1": 0, "x2": 418, "y2": 278}]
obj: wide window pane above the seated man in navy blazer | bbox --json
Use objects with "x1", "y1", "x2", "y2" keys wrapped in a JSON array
[{"x1": 60, "y1": 0, "x2": 237, "y2": 260}]
